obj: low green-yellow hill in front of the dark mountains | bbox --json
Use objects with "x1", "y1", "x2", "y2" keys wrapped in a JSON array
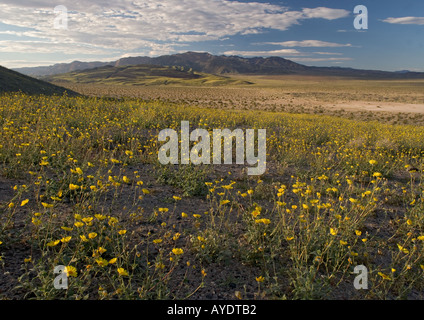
[{"x1": 42, "y1": 65, "x2": 252, "y2": 86}]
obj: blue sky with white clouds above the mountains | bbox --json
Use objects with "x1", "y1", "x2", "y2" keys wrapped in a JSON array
[{"x1": 0, "y1": 0, "x2": 424, "y2": 71}]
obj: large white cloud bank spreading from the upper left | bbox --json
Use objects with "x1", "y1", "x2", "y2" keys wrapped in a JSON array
[{"x1": 0, "y1": 0, "x2": 350, "y2": 55}]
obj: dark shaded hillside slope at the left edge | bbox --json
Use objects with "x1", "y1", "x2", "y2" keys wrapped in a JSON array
[{"x1": 0, "y1": 66, "x2": 76, "y2": 95}]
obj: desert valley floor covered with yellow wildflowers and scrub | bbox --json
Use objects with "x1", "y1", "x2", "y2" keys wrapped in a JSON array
[{"x1": 0, "y1": 79, "x2": 424, "y2": 300}]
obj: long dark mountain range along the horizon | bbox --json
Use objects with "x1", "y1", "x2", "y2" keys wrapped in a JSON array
[{"x1": 14, "y1": 52, "x2": 424, "y2": 79}]
